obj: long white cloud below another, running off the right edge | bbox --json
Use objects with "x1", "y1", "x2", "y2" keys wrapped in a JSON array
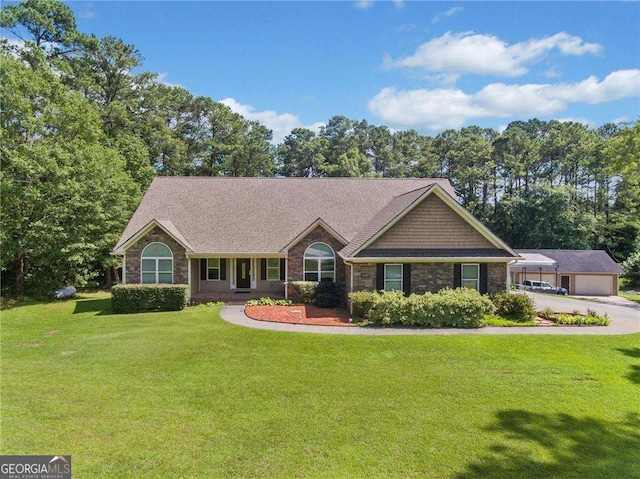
[{"x1": 368, "y1": 70, "x2": 640, "y2": 131}]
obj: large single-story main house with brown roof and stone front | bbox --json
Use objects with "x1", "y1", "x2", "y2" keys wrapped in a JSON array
[{"x1": 112, "y1": 177, "x2": 518, "y2": 300}]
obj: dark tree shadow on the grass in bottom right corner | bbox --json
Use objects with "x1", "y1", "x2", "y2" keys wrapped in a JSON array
[{"x1": 456, "y1": 410, "x2": 640, "y2": 479}]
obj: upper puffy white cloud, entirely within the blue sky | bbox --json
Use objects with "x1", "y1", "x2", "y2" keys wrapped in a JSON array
[{"x1": 387, "y1": 32, "x2": 602, "y2": 77}]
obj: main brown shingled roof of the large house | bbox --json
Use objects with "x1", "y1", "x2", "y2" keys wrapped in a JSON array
[{"x1": 113, "y1": 177, "x2": 457, "y2": 254}]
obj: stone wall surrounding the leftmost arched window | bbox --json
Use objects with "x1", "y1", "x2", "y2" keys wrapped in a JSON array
[{"x1": 125, "y1": 227, "x2": 188, "y2": 284}]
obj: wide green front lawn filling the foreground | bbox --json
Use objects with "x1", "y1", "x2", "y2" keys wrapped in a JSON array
[{"x1": 0, "y1": 294, "x2": 640, "y2": 479}]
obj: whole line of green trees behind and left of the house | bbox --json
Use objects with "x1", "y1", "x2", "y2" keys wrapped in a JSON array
[{"x1": 0, "y1": 0, "x2": 640, "y2": 294}]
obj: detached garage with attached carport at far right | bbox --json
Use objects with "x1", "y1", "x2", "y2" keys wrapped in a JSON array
[{"x1": 511, "y1": 249, "x2": 622, "y2": 296}]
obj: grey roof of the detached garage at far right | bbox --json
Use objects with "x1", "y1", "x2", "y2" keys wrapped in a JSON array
[{"x1": 512, "y1": 249, "x2": 622, "y2": 274}]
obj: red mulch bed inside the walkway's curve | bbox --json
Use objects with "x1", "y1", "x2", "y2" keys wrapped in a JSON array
[{"x1": 244, "y1": 304, "x2": 351, "y2": 326}]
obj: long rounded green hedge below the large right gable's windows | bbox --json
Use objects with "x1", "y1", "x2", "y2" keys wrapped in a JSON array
[{"x1": 350, "y1": 288, "x2": 494, "y2": 328}]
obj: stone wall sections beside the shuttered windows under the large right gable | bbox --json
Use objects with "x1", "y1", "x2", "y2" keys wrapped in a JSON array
[{"x1": 353, "y1": 263, "x2": 507, "y2": 293}]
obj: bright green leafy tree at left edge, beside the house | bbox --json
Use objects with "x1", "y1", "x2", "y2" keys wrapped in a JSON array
[{"x1": 0, "y1": 51, "x2": 140, "y2": 295}]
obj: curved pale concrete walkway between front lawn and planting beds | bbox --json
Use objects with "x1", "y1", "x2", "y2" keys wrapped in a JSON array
[{"x1": 220, "y1": 304, "x2": 640, "y2": 336}]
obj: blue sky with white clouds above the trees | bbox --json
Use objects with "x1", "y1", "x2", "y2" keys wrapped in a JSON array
[{"x1": 21, "y1": 0, "x2": 640, "y2": 143}]
